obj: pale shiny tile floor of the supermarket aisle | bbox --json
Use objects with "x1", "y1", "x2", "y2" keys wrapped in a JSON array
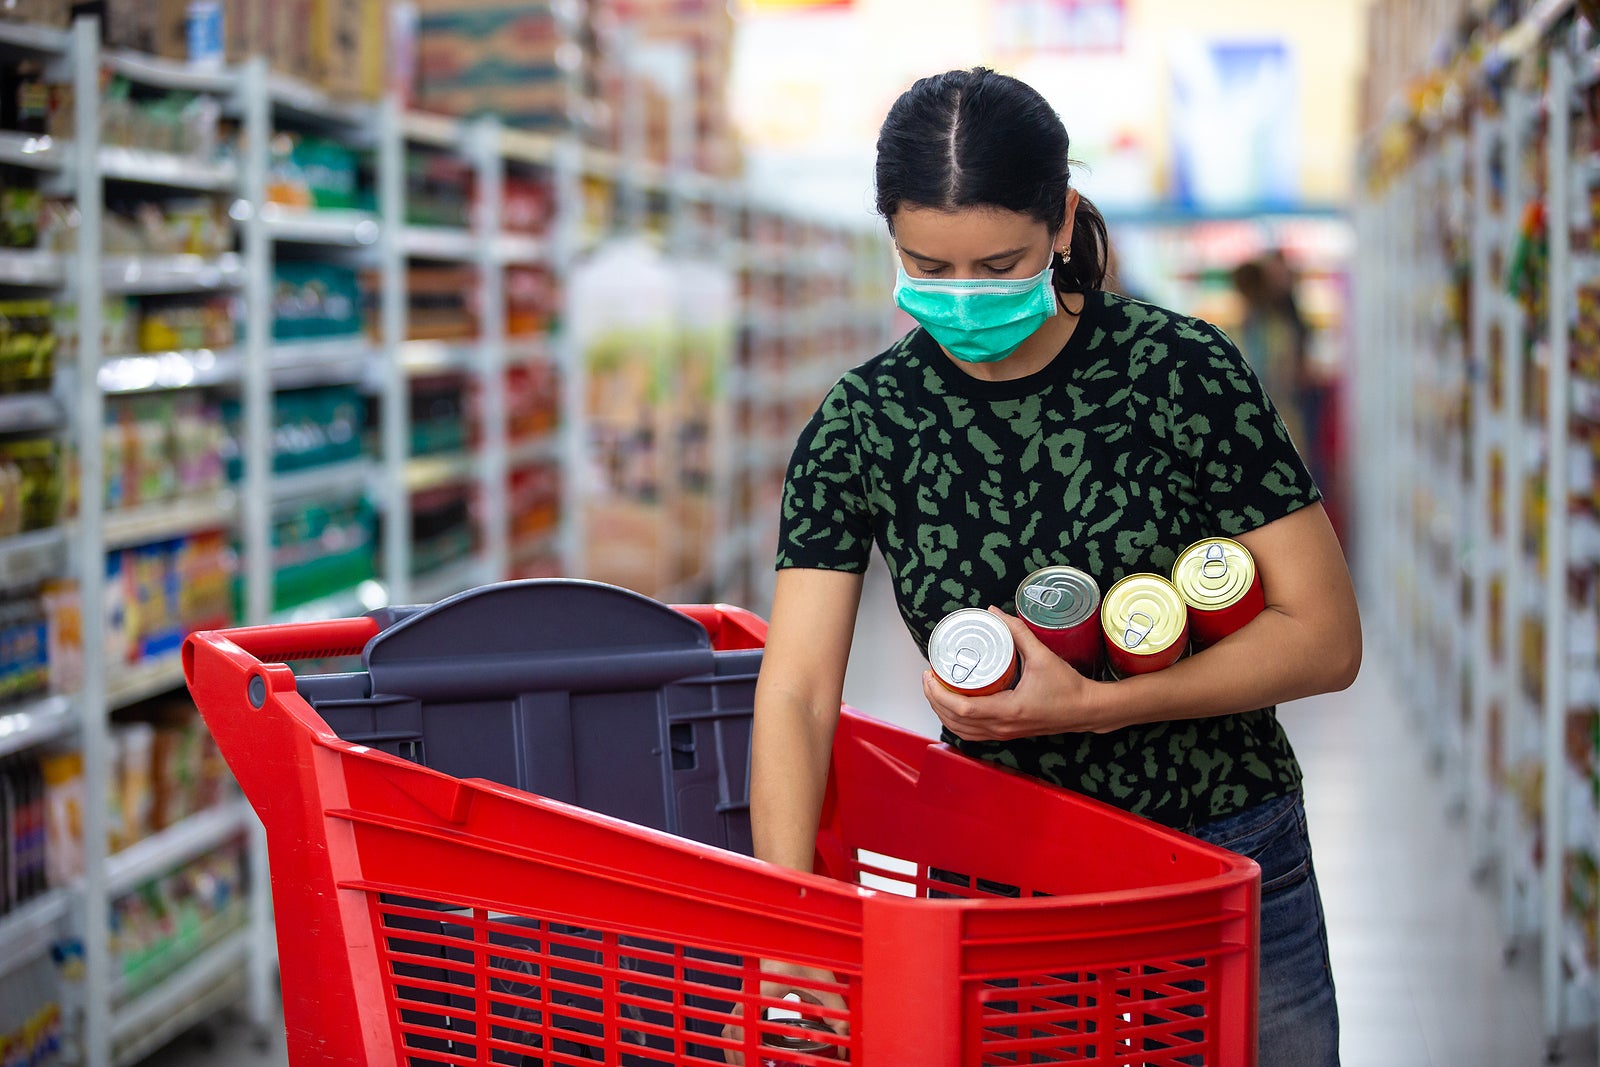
[{"x1": 147, "y1": 568, "x2": 1600, "y2": 1067}]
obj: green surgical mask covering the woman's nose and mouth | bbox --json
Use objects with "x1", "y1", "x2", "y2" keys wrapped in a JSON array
[{"x1": 894, "y1": 264, "x2": 1056, "y2": 363}]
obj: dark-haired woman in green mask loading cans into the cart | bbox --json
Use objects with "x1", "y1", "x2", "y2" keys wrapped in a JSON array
[{"x1": 752, "y1": 69, "x2": 1360, "y2": 1067}]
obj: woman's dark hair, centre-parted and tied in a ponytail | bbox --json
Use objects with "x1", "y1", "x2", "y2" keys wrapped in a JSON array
[{"x1": 877, "y1": 67, "x2": 1110, "y2": 293}]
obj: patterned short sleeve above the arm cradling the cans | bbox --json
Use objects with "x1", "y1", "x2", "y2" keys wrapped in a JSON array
[{"x1": 1168, "y1": 323, "x2": 1322, "y2": 537}]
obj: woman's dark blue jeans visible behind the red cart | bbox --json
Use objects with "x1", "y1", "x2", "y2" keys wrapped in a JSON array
[{"x1": 1190, "y1": 793, "x2": 1339, "y2": 1067}]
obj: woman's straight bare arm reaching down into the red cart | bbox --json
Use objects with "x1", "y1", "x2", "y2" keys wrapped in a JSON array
[{"x1": 750, "y1": 569, "x2": 862, "y2": 870}]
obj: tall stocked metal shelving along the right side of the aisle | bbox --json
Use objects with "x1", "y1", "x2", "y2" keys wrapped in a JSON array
[{"x1": 1357, "y1": 0, "x2": 1600, "y2": 1061}]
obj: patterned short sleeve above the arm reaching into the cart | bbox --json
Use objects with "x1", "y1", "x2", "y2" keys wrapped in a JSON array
[{"x1": 778, "y1": 379, "x2": 872, "y2": 574}]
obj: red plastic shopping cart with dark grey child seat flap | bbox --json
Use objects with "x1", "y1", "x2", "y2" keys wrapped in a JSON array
[{"x1": 184, "y1": 579, "x2": 1259, "y2": 1067}]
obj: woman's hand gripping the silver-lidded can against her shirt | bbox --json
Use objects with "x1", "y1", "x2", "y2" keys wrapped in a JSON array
[{"x1": 922, "y1": 608, "x2": 1112, "y2": 741}]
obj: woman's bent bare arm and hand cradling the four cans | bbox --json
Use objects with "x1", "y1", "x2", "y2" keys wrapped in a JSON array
[{"x1": 923, "y1": 504, "x2": 1362, "y2": 741}]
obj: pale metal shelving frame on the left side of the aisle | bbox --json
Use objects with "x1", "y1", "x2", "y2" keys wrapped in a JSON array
[{"x1": 0, "y1": 12, "x2": 891, "y2": 1067}]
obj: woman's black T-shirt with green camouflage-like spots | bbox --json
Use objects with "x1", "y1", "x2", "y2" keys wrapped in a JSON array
[{"x1": 778, "y1": 293, "x2": 1320, "y2": 829}]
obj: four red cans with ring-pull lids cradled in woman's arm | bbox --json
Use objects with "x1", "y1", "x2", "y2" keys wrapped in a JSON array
[{"x1": 928, "y1": 537, "x2": 1266, "y2": 696}]
